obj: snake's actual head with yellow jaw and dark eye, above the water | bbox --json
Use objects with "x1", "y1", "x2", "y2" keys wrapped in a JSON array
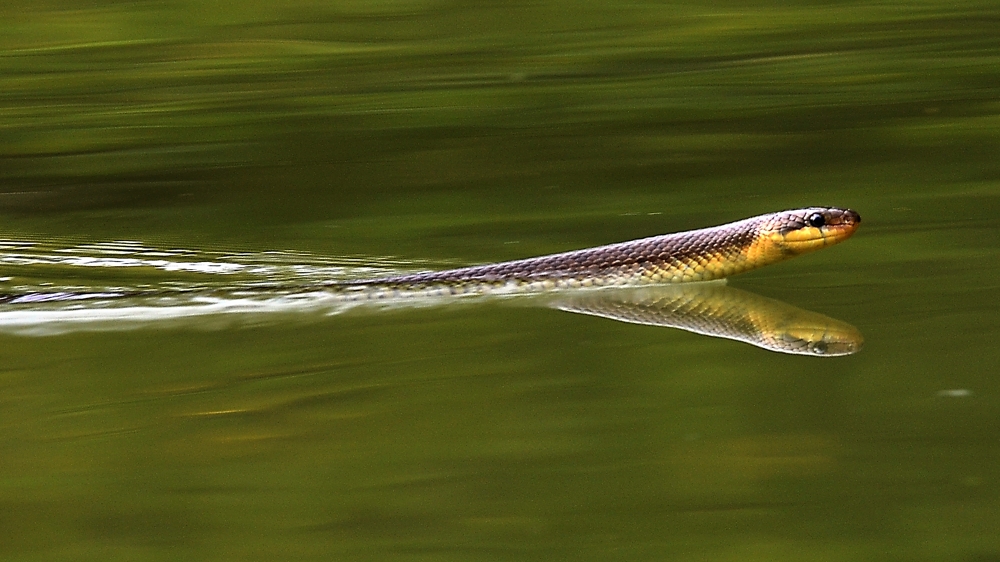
[{"x1": 761, "y1": 207, "x2": 861, "y2": 256}]
